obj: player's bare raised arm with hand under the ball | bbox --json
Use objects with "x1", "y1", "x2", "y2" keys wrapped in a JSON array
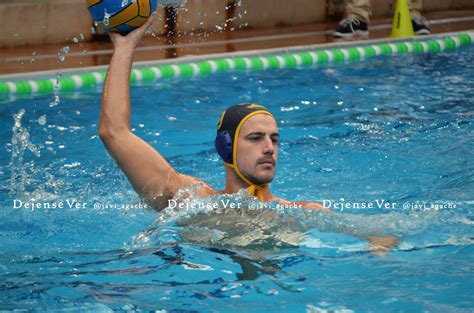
[{"x1": 99, "y1": 13, "x2": 206, "y2": 209}]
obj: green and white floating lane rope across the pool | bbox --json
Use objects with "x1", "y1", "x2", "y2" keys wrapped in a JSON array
[{"x1": 0, "y1": 31, "x2": 474, "y2": 97}]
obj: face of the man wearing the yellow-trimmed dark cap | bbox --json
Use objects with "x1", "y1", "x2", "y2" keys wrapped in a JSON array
[{"x1": 237, "y1": 114, "x2": 279, "y2": 185}]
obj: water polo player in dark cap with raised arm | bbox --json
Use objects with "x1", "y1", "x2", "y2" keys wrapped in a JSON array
[{"x1": 99, "y1": 13, "x2": 324, "y2": 210}]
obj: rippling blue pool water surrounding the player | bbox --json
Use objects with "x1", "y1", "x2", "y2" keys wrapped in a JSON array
[{"x1": 0, "y1": 48, "x2": 474, "y2": 312}]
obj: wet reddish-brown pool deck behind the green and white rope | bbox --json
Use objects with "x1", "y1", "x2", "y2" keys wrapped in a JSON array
[{"x1": 0, "y1": 10, "x2": 474, "y2": 79}]
